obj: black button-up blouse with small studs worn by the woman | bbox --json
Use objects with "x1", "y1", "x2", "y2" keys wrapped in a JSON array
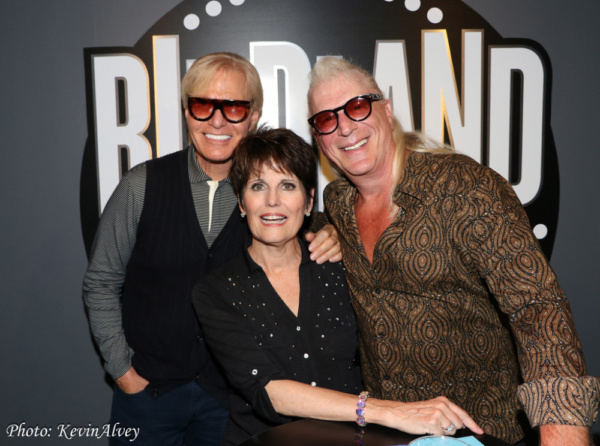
[{"x1": 193, "y1": 241, "x2": 362, "y2": 445}]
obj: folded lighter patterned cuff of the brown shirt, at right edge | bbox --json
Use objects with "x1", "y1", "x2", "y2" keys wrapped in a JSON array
[{"x1": 518, "y1": 376, "x2": 600, "y2": 427}]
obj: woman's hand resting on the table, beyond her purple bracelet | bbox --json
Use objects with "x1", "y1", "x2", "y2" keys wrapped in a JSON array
[{"x1": 372, "y1": 396, "x2": 483, "y2": 435}]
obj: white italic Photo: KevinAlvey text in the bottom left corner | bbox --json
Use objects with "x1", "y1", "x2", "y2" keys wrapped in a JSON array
[{"x1": 6, "y1": 421, "x2": 140, "y2": 441}]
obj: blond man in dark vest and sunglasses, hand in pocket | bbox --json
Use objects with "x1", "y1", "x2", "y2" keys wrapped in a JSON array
[{"x1": 83, "y1": 53, "x2": 339, "y2": 446}]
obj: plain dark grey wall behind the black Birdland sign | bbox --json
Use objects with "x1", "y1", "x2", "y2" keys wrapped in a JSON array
[{"x1": 0, "y1": 0, "x2": 600, "y2": 445}]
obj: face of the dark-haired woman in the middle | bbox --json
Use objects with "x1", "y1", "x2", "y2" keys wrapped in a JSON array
[{"x1": 240, "y1": 166, "x2": 314, "y2": 251}]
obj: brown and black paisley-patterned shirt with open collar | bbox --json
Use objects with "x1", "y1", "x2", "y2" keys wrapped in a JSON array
[{"x1": 324, "y1": 152, "x2": 600, "y2": 442}]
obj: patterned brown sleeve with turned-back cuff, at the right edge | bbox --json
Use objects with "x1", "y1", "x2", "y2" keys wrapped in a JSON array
[{"x1": 465, "y1": 166, "x2": 600, "y2": 426}]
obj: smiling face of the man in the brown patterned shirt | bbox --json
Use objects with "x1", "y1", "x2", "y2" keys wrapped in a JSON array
[{"x1": 309, "y1": 75, "x2": 395, "y2": 182}]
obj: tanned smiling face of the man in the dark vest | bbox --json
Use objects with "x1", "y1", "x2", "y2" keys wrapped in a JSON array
[{"x1": 185, "y1": 70, "x2": 259, "y2": 180}]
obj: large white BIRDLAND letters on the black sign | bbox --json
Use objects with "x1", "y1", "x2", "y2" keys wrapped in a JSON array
[{"x1": 90, "y1": 35, "x2": 545, "y2": 210}]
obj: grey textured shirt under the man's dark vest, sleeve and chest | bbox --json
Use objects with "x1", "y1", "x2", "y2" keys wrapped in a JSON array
[{"x1": 83, "y1": 146, "x2": 237, "y2": 379}]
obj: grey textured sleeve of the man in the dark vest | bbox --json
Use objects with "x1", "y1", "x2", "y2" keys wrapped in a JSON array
[{"x1": 83, "y1": 165, "x2": 146, "y2": 384}]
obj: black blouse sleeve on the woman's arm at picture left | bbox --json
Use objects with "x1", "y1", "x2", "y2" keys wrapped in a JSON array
[{"x1": 192, "y1": 275, "x2": 290, "y2": 424}]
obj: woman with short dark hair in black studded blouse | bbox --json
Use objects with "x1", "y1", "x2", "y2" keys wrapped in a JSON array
[{"x1": 193, "y1": 129, "x2": 474, "y2": 445}]
